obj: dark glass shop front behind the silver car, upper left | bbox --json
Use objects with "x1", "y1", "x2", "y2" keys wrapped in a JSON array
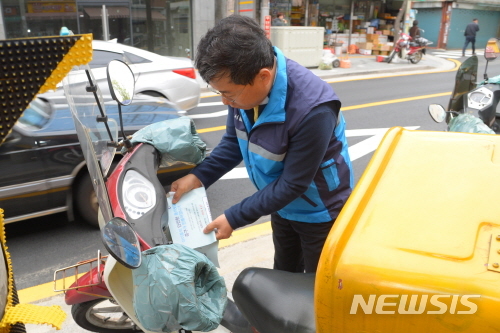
[{"x1": 1, "y1": 0, "x2": 193, "y2": 56}]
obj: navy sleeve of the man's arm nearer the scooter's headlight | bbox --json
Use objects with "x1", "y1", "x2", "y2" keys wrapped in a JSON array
[{"x1": 191, "y1": 108, "x2": 243, "y2": 188}]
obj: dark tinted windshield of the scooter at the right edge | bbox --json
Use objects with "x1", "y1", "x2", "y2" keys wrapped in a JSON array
[{"x1": 448, "y1": 56, "x2": 478, "y2": 111}]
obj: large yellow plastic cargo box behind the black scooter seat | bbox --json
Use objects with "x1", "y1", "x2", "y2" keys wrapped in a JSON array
[{"x1": 315, "y1": 127, "x2": 500, "y2": 333}]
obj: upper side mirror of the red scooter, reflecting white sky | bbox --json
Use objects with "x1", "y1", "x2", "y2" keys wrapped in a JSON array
[{"x1": 107, "y1": 60, "x2": 135, "y2": 105}]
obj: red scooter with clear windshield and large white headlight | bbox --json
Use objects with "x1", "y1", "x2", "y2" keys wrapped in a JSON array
[{"x1": 54, "y1": 60, "x2": 252, "y2": 333}]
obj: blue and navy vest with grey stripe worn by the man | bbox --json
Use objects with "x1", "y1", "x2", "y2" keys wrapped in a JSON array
[{"x1": 230, "y1": 47, "x2": 354, "y2": 223}]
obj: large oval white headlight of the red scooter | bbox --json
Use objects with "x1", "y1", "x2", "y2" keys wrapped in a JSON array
[{"x1": 122, "y1": 170, "x2": 156, "y2": 219}]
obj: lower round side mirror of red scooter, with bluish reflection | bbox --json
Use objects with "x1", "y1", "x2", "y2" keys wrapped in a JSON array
[{"x1": 101, "y1": 217, "x2": 141, "y2": 269}]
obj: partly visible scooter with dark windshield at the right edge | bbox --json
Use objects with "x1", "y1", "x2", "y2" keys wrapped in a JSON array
[{"x1": 429, "y1": 38, "x2": 500, "y2": 134}]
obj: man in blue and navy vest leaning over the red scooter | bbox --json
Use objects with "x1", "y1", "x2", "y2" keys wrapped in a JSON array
[{"x1": 172, "y1": 15, "x2": 353, "y2": 272}]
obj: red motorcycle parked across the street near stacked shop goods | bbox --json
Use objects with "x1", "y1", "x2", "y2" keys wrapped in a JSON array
[{"x1": 386, "y1": 29, "x2": 432, "y2": 64}]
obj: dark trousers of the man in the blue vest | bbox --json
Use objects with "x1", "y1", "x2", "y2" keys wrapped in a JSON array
[{"x1": 271, "y1": 213, "x2": 334, "y2": 273}]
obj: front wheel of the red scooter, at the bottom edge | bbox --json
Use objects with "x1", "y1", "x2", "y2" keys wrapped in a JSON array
[{"x1": 71, "y1": 298, "x2": 142, "y2": 333}]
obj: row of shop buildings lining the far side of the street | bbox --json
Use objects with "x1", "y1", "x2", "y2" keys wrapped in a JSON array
[{"x1": 0, "y1": 0, "x2": 500, "y2": 57}]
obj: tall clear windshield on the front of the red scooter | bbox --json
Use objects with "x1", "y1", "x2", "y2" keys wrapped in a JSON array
[{"x1": 63, "y1": 65, "x2": 118, "y2": 221}]
